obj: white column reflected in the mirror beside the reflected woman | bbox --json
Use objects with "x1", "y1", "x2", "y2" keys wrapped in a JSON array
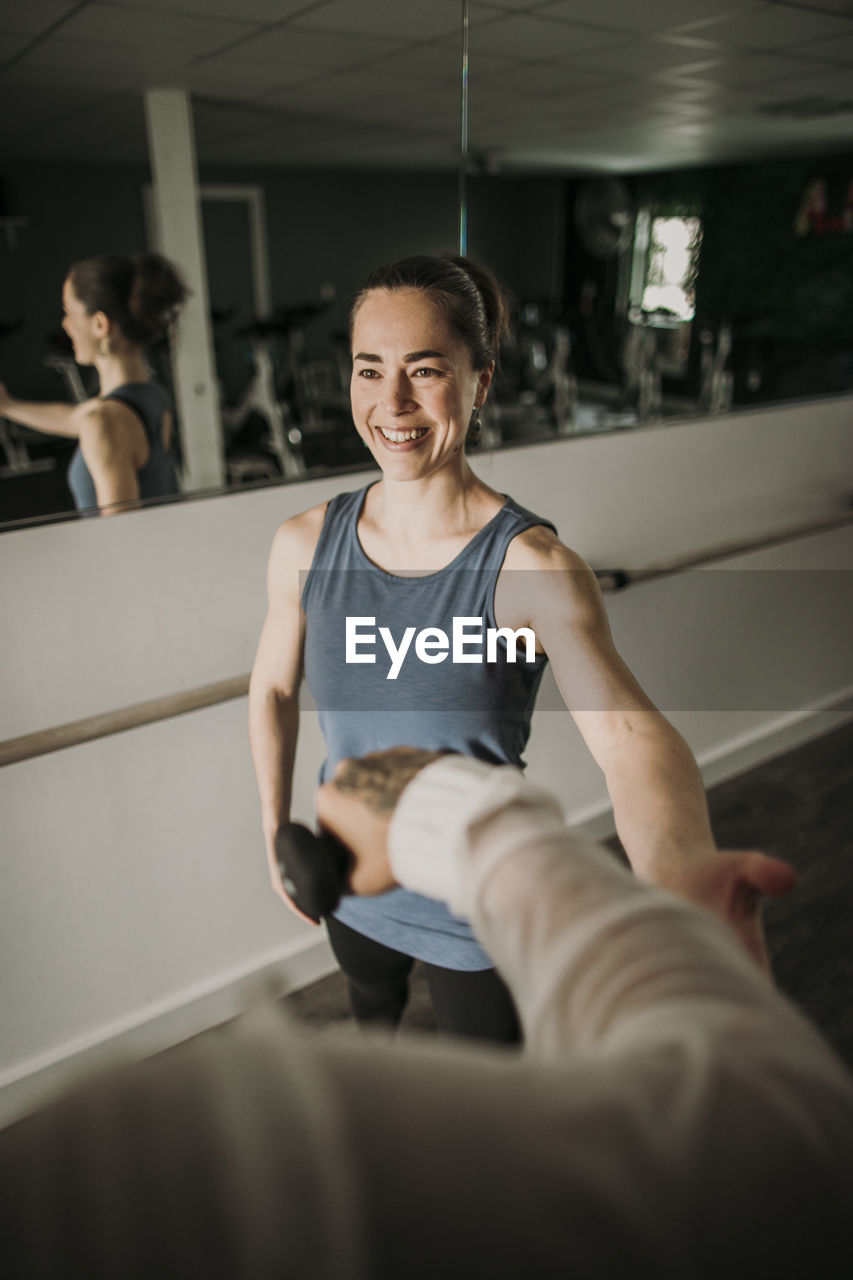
[{"x1": 145, "y1": 88, "x2": 225, "y2": 490}]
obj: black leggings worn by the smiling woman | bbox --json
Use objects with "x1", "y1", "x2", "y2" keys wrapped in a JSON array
[{"x1": 325, "y1": 915, "x2": 521, "y2": 1044}]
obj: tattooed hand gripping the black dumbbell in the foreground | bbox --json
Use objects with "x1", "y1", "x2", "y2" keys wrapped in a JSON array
[{"x1": 316, "y1": 746, "x2": 441, "y2": 893}]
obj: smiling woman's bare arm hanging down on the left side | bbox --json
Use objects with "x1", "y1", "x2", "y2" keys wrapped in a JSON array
[{"x1": 248, "y1": 507, "x2": 325, "y2": 923}]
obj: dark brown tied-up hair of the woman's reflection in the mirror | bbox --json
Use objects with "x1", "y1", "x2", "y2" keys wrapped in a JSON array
[{"x1": 68, "y1": 253, "x2": 190, "y2": 346}]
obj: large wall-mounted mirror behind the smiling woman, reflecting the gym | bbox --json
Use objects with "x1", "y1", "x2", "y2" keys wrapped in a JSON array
[{"x1": 0, "y1": 0, "x2": 853, "y2": 521}]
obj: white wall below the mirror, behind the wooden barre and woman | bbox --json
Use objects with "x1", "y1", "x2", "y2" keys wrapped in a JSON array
[{"x1": 0, "y1": 398, "x2": 853, "y2": 1115}]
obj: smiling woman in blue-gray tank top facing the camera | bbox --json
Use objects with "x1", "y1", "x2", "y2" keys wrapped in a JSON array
[{"x1": 250, "y1": 257, "x2": 772, "y2": 1042}]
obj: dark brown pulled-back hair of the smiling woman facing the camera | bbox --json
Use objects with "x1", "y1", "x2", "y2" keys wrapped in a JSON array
[{"x1": 350, "y1": 253, "x2": 510, "y2": 370}]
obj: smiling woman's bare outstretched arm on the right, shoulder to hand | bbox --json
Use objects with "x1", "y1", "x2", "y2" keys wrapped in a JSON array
[{"x1": 496, "y1": 527, "x2": 794, "y2": 964}]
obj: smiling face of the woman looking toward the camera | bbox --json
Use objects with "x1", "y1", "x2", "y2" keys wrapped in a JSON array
[{"x1": 351, "y1": 289, "x2": 493, "y2": 480}]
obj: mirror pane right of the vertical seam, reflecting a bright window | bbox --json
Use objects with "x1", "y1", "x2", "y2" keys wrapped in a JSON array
[{"x1": 469, "y1": 0, "x2": 853, "y2": 443}]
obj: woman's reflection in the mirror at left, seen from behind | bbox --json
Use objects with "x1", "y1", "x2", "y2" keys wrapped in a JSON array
[{"x1": 0, "y1": 253, "x2": 187, "y2": 515}]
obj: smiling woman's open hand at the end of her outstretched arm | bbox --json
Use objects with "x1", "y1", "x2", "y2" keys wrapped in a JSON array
[{"x1": 676, "y1": 849, "x2": 797, "y2": 974}]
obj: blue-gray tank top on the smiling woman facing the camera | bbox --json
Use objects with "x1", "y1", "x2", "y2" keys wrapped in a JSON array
[{"x1": 302, "y1": 489, "x2": 553, "y2": 970}]
